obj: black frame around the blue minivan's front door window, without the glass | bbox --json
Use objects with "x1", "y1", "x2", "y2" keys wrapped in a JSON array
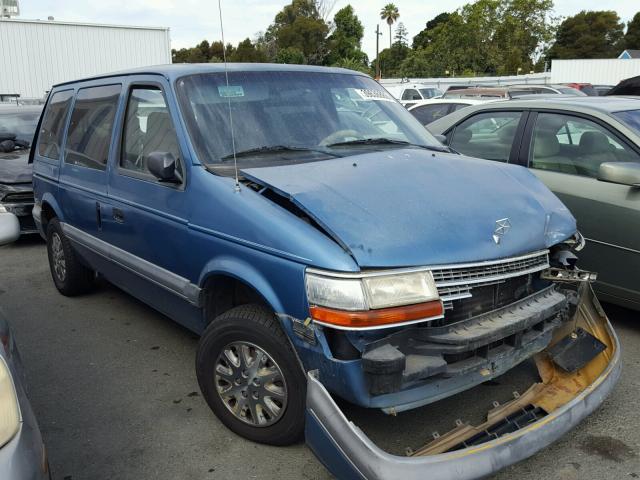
[{"x1": 114, "y1": 79, "x2": 188, "y2": 190}]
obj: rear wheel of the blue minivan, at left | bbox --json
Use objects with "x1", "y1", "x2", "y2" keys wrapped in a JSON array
[{"x1": 47, "y1": 218, "x2": 95, "y2": 297}]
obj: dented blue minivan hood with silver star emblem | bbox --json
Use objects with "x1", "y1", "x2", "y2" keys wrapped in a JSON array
[{"x1": 243, "y1": 149, "x2": 576, "y2": 268}]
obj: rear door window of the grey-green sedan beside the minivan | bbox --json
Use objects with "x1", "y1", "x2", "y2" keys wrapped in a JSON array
[{"x1": 450, "y1": 111, "x2": 522, "y2": 162}]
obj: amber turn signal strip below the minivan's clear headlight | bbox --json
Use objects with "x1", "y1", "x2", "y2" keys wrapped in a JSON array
[{"x1": 309, "y1": 300, "x2": 444, "y2": 330}]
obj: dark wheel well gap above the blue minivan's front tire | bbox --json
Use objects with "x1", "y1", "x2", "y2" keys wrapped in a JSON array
[{"x1": 203, "y1": 275, "x2": 271, "y2": 324}]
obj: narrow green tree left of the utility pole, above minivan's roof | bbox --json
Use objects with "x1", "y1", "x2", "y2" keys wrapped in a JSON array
[{"x1": 327, "y1": 5, "x2": 368, "y2": 68}]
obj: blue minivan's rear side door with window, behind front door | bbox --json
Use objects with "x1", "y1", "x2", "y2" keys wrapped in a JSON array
[{"x1": 58, "y1": 84, "x2": 122, "y2": 239}]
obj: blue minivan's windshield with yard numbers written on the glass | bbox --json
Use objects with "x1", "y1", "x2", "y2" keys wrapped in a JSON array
[{"x1": 177, "y1": 71, "x2": 442, "y2": 174}]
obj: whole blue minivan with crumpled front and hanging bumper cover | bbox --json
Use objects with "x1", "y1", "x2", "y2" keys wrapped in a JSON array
[{"x1": 31, "y1": 64, "x2": 620, "y2": 478}]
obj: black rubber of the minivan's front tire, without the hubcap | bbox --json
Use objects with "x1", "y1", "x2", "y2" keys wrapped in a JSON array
[{"x1": 196, "y1": 305, "x2": 307, "y2": 445}]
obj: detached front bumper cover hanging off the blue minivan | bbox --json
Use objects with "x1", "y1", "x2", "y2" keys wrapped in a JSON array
[{"x1": 306, "y1": 283, "x2": 621, "y2": 480}]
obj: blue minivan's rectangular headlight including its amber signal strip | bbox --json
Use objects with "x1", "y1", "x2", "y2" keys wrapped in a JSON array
[{"x1": 305, "y1": 270, "x2": 444, "y2": 330}]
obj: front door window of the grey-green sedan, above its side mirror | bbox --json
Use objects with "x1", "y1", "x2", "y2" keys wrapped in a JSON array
[{"x1": 529, "y1": 113, "x2": 640, "y2": 178}]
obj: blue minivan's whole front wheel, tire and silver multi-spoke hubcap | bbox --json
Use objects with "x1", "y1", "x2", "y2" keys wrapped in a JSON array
[{"x1": 196, "y1": 305, "x2": 306, "y2": 445}]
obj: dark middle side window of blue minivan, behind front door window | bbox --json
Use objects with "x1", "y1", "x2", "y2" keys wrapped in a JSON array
[{"x1": 65, "y1": 85, "x2": 121, "y2": 170}]
